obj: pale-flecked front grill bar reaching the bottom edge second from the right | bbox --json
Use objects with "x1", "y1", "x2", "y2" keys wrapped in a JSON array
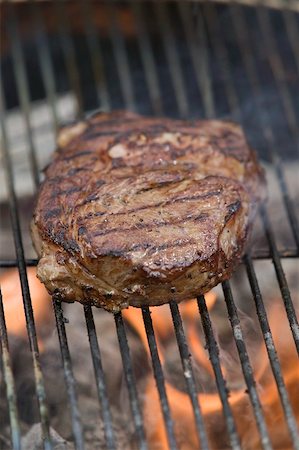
[{"x1": 222, "y1": 281, "x2": 272, "y2": 450}]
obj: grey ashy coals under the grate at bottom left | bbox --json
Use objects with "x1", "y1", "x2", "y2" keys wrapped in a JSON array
[{"x1": 0, "y1": 304, "x2": 148, "y2": 450}]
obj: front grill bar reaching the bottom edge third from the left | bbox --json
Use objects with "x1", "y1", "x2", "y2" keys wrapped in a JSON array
[{"x1": 53, "y1": 298, "x2": 84, "y2": 450}]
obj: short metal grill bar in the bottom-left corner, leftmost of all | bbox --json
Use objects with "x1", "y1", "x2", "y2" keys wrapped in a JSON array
[{"x1": 0, "y1": 289, "x2": 21, "y2": 450}]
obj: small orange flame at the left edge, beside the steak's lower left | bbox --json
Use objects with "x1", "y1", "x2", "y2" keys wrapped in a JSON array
[{"x1": 0, "y1": 267, "x2": 51, "y2": 349}]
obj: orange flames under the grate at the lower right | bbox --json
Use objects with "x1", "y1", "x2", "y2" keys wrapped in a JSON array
[{"x1": 124, "y1": 292, "x2": 299, "y2": 450}]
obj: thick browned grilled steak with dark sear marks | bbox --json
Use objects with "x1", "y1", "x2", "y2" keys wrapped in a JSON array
[{"x1": 32, "y1": 112, "x2": 264, "y2": 312}]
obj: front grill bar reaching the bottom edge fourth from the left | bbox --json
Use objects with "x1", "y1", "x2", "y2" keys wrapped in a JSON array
[{"x1": 84, "y1": 306, "x2": 116, "y2": 450}]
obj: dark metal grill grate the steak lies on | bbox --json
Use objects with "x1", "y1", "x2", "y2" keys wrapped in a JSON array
[{"x1": 0, "y1": 0, "x2": 299, "y2": 450}]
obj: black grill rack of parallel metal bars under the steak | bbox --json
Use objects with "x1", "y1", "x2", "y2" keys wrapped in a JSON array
[{"x1": 0, "y1": 1, "x2": 299, "y2": 450}]
